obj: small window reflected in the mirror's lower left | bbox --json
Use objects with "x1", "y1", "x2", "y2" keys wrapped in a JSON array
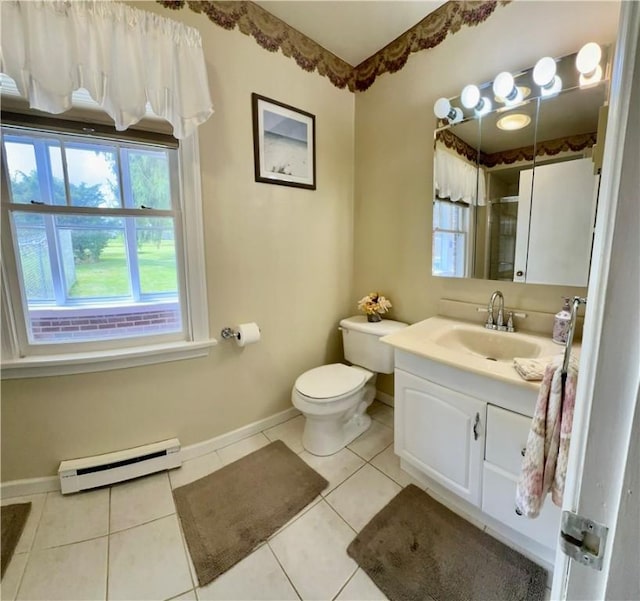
[{"x1": 432, "y1": 199, "x2": 470, "y2": 277}]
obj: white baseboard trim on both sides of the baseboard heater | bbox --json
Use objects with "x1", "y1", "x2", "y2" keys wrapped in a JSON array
[{"x1": 0, "y1": 407, "x2": 300, "y2": 499}]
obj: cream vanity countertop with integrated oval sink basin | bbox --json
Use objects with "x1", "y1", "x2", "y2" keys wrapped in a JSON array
[{"x1": 380, "y1": 316, "x2": 577, "y2": 390}]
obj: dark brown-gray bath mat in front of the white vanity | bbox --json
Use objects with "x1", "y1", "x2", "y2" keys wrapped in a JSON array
[{"x1": 347, "y1": 485, "x2": 546, "y2": 601}]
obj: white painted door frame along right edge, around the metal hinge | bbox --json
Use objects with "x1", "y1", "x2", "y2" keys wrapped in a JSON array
[{"x1": 551, "y1": 2, "x2": 640, "y2": 600}]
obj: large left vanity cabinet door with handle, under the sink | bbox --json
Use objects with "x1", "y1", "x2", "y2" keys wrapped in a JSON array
[{"x1": 395, "y1": 369, "x2": 487, "y2": 506}]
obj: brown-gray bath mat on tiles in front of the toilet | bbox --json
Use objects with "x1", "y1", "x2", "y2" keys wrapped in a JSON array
[{"x1": 173, "y1": 440, "x2": 328, "y2": 586}]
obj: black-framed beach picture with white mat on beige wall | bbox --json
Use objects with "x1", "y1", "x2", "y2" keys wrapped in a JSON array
[{"x1": 251, "y1": 93, "x2": 316, "y2": 190}]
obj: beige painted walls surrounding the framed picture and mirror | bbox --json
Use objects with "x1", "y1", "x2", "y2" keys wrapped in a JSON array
[{"x1": 2, "y1": 1, "x2": 617, "y2": 481}]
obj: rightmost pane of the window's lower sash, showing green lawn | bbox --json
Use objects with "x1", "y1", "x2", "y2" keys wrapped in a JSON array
[{"x1": 136, "y1": 217, "x2": 178, "y2": 298}]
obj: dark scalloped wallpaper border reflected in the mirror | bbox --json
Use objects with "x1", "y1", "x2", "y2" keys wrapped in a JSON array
[{"x1": 435, "y1": 129, "x2": 597, "y2": 168}]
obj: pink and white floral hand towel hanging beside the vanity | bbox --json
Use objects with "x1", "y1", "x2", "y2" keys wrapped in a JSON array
[{"x1": 516, "y1": 363, "x2": 577, "y2": 518}]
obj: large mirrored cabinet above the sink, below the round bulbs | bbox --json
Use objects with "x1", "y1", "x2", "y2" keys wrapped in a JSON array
[{"x1": 432, "y1": 48, "x2": 609, "y2": 286}]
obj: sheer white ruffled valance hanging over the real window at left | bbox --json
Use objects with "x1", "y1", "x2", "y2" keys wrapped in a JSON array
[{"x1": 0, "y1": 0, "x2": 213, "y2": 139}]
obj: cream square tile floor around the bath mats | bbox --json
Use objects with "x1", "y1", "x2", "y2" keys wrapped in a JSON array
[{"x1": 1, "y1": 401, "x2": 552, "y2": 601}]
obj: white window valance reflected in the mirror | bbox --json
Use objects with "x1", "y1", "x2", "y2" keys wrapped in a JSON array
[{"x1": 434, "y1": 146, "x2": 486, "y2": 205}]
